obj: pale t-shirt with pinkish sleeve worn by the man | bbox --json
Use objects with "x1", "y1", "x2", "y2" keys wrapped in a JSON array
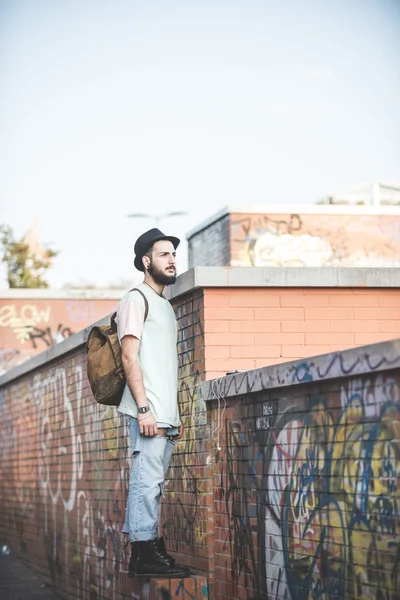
[{"x1": 116, "y1": 283, "x2": 180, "y2": 427}]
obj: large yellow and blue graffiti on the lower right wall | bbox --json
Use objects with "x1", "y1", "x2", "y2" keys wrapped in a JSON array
[{"x1": 285, "y1": 394, "x2": 400, "y2": 600}]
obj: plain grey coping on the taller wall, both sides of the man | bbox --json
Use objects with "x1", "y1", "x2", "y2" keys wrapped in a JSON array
[{"x1": 0, "y1": 267, "x2": 400, "y2": 387}]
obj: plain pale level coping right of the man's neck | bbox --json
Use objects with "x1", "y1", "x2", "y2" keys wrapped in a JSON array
[{"x1": 165, "y1": 267, "x2": 400, "y2": 299}]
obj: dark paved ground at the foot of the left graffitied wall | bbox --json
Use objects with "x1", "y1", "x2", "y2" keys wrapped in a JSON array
[{"x1": 0, "y1": 548, "x2": 60, "y2": 600}]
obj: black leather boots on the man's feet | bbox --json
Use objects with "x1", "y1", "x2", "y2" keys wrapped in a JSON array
[{"x1": 128, "y1": 539, "x2": 188, "y2": 578}]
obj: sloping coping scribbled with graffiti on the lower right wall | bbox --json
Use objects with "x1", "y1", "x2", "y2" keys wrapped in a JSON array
[{"x1": 203, "y1": 339, "x2": 400, "y2": 401}]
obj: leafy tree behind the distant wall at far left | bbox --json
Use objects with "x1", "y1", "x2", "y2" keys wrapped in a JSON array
[{"x1": 0, "y1": 225, "x2": 58, "y2": 288}]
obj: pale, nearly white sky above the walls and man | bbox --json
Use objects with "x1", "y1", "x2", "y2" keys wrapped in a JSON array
[{"x1": 0, "y1": 0, "x2": 400, "y2": 287}]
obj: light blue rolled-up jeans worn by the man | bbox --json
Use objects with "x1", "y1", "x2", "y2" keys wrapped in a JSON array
[{"x1": 122, "y1": 415, "x2": 178, "y2": 542}]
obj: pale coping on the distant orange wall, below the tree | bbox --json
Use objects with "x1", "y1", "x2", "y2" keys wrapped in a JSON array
[{"x1": 0, "y1": 288, "x2": 126, "y2": 300}]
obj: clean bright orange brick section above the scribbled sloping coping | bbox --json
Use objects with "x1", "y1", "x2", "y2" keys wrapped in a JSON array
[{"x1": 204, "y1": 288, "x2": 400, "y2": 379}]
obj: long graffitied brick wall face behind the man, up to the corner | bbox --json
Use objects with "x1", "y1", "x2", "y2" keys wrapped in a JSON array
[{"x1": 0, "y1": 292, "x2": 209, "y2": 600}]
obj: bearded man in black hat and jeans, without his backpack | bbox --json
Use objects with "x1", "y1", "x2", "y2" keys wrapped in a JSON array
[{"x1": 117, "y1": 229, "x2": 190, "y2": 577}]
